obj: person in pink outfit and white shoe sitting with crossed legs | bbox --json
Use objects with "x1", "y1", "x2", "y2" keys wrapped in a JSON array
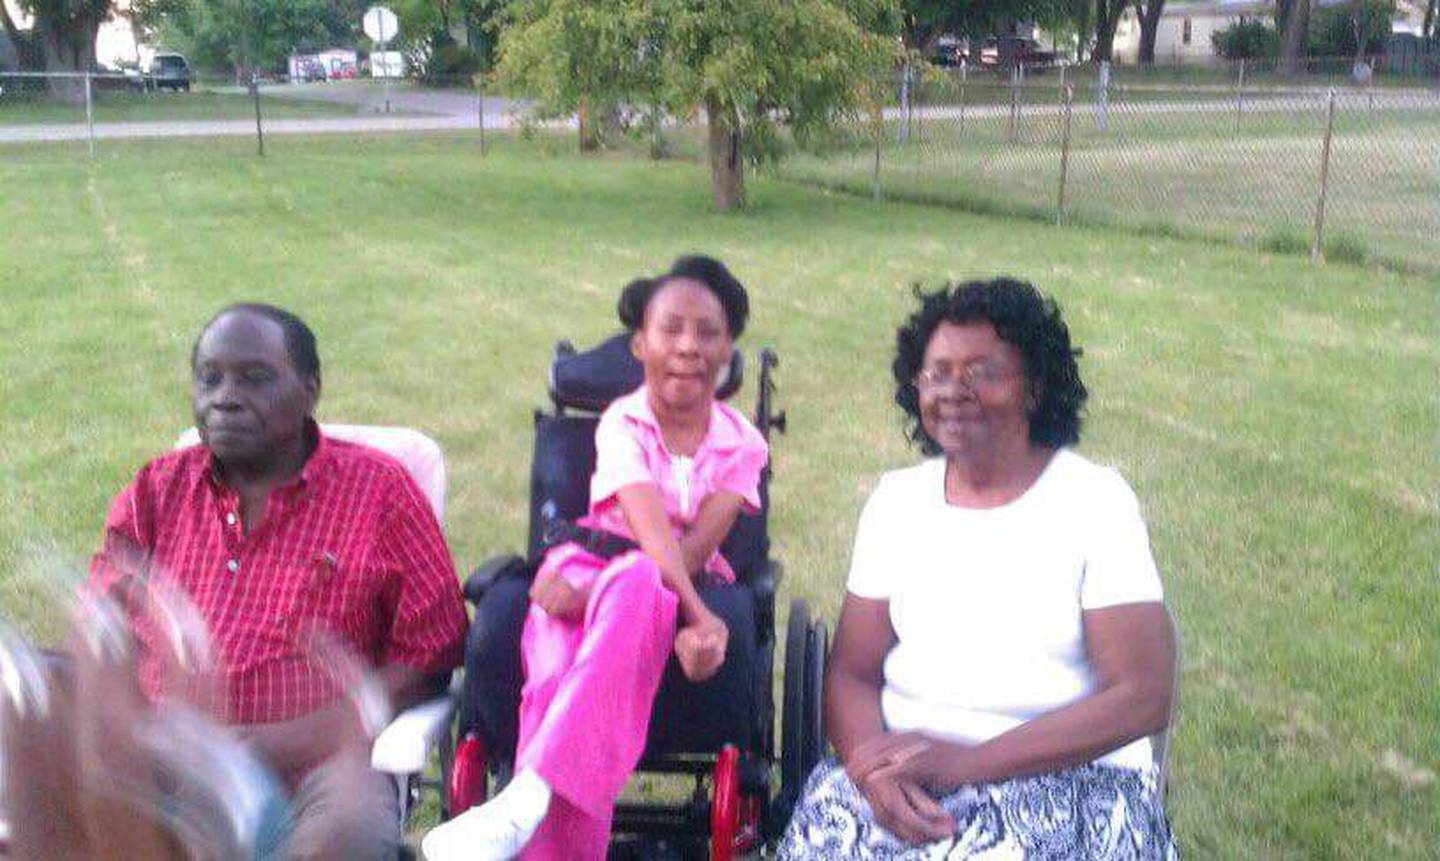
[{"x1": 423, "y1": 256, "x2": 768, "y2": 861}]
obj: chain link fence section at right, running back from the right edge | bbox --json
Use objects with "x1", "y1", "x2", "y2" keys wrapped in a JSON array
[{"x1": 779, "y1": 68, "x2": 1440, "y2": 271}]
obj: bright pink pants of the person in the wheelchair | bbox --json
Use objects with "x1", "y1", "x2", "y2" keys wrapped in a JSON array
[{"x1": 516, "y1": 551, "x2": 677, "y2": 861}]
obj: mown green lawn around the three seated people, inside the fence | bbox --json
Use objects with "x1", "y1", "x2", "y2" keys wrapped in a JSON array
[{"x1": 0, "y1": 135, "x2": 1440, "y2": 860}]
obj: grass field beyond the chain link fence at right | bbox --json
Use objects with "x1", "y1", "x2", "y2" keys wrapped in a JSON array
[{"x1": 780, "y1": 88, "x2": 1440, "y2": 272}]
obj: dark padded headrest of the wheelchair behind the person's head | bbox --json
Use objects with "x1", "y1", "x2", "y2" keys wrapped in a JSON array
[{"x1": 550, "y1": 331, "x2": 744, "y2": 412}]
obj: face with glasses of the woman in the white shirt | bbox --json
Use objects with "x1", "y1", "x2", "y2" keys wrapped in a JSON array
[{"x1": 916, "y1": 321, "x2": 1030, "y2": 456}]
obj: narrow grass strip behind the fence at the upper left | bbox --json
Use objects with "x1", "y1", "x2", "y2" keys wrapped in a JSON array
[{"x1": 0, "y1": 89, "x2": 365, "y2": 127}]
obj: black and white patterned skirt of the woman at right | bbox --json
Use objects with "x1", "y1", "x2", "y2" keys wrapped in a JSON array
[{"x1": 779, "y1": 757, "x2": 1178, "y2": 861}]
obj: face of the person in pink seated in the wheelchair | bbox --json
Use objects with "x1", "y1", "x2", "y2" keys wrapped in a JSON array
[{"x1": 631, "y1": 278, "x2": 733, "y2": 412}]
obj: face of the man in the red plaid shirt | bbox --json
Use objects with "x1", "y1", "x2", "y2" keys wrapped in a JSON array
[{"x1": 190, "y1": 311, "x2": 320, "y2": 471}]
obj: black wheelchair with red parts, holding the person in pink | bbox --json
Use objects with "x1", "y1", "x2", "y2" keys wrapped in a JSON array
[{"x1": 442, "y1": 334, "x2": 828, "y2": 861}]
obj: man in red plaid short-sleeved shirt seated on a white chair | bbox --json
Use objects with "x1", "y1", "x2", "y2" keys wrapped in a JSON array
[{"x1": 91, "y1": 305, "x2": 467, "y2": 858}]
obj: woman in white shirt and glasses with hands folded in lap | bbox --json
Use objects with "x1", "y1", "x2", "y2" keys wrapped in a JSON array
[{"x1": 780, "y1": 279, "x2": 1175, "y2": 860}]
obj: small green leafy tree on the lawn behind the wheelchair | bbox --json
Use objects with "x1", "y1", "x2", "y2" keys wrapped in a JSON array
[{"x1": 500, "y1": 0, "x2": 897, "y2": 210}]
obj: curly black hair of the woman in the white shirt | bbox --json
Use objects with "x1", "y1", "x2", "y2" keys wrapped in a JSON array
[{"x1": 890, "y1": 276, "x2": 1089, "y2": 455}]
